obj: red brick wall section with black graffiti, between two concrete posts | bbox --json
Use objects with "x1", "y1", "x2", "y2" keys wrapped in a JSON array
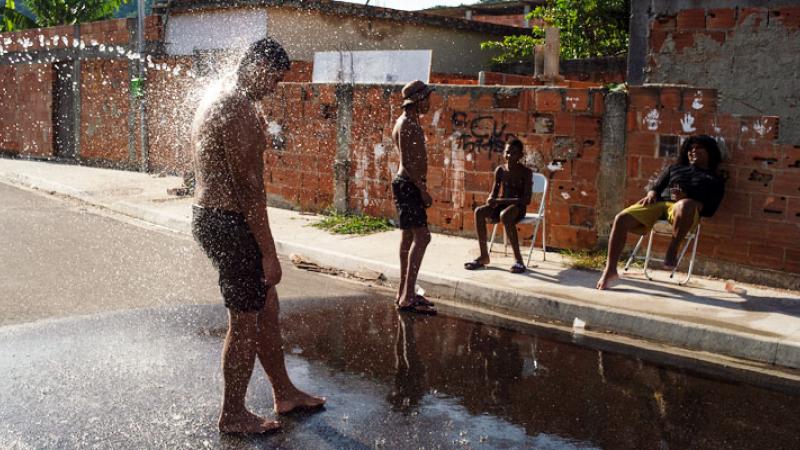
[{"x1": 350, "y1": 87, "x2": 603, "y2": 248}]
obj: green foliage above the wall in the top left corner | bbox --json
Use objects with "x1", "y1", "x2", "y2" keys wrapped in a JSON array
[{"x1": 0, "y1": 0, "x2": 130, "y2": 31}]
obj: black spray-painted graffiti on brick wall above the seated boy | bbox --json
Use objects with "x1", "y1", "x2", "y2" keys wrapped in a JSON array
[{"x1": 450, "y1": 111, "x2": 508, "y2": 155}]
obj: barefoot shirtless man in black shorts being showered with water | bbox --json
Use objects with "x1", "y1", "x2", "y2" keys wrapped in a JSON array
[{"x1": 192, "y1": 38, "x2": 325, "y2": 433}]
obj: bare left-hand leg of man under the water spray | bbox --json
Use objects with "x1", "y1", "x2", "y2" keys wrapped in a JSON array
[{"x1": 219, "y1": 310, "x2": 280, "y2": 433}]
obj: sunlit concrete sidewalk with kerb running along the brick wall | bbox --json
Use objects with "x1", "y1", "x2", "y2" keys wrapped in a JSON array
[{"x1": 0, "y1": 158, "x2": 800, "y2": 369}]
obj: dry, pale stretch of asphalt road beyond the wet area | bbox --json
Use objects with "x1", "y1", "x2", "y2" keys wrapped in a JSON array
[{"x1": 0, "y1": 183, "x2": 367, "y2": 326}]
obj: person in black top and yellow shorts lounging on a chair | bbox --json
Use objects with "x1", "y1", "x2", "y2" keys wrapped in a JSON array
[{"x1": 597, "y1": 135, "x2": 725, "y2": 289}]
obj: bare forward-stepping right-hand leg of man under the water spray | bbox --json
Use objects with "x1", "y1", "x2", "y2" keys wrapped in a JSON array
[{"x1": 257, "y1": 286, "x2": 325, "y2": 414}]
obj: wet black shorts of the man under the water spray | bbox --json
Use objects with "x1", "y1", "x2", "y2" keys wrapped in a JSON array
[{"x1": 192, "y1": 206, "x2": 267, "y2": 312}]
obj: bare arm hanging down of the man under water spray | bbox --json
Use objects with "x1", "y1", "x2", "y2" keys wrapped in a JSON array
[{"x1": 223, "y1": 101, "x2": 282, "y2": 286}]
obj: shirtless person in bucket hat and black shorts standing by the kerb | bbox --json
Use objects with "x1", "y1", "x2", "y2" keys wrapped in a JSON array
[{"x1": 392, "y1": 80, "x2": 436, "y2": 314}]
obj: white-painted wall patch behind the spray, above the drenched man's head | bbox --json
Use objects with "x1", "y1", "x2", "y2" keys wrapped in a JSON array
[{"x1": 166, "y1": 9, "x2": 267, "y2": 55}]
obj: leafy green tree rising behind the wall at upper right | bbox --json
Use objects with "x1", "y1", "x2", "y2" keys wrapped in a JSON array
[{"x1": 481, "y1": 0, "x2": 630, "y2": 64}]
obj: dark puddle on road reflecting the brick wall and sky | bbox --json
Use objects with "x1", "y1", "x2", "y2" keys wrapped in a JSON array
[{"x1": 283, "y1": 299, "x2": 800, "y2": 449}]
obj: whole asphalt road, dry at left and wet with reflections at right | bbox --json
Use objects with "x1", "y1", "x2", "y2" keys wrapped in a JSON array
[{"x1": 0, "y1": 184, "x2": 800, "y2": 449}]
